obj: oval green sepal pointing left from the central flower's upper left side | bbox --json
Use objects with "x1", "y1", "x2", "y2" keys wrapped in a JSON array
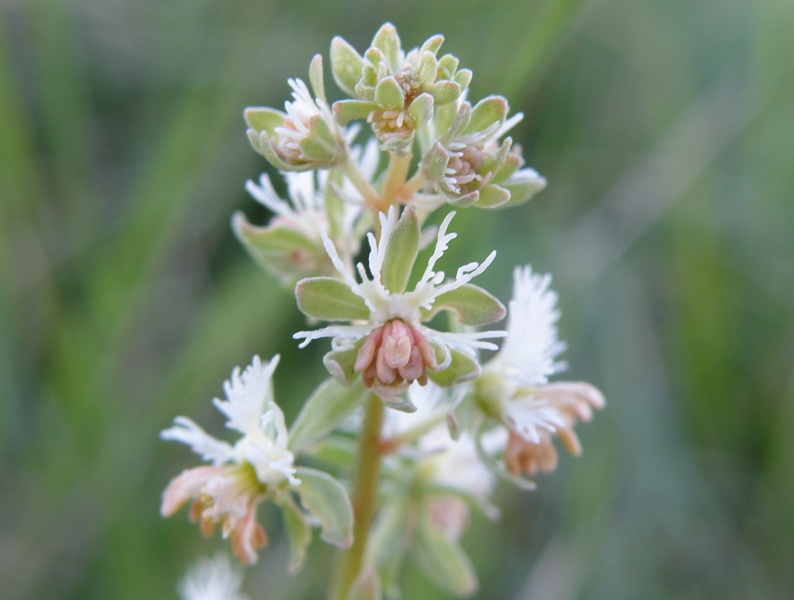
[{"x1": 295, "y1": 277, "x2": 369, "y2": 321}]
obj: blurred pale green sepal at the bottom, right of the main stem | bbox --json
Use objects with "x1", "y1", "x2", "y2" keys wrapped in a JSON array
[{"x1": 413, "y1": 517, "x2": 478, "y2": 596}]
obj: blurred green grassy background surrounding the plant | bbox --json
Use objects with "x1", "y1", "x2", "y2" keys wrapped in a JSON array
[{"x1": 0, "y1": 0, "x2": 794, "y2": 600}]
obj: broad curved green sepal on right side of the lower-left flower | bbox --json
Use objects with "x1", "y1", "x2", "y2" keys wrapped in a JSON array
[{"x1": 295, "y1": 467, "x2": 353, "y2": 548}]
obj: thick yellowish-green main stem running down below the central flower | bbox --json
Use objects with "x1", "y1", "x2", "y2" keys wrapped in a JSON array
[{"x1": 330, "y1": 394, "x2": 384, "y2": 600}]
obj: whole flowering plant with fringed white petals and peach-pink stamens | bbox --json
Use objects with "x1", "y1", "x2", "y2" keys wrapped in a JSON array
[{"x1": 161, "y1": 23, "x2": 604, "y2": 600}]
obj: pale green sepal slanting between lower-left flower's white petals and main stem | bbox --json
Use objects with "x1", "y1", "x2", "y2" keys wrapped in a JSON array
[{"x1": 289, "y1": 379, "x2": 367, "y2": 454}]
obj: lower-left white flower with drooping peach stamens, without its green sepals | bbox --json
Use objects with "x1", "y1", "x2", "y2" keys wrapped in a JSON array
[{"x1": 160, "y1": 356, "x2": 300, "y2": 563}]
